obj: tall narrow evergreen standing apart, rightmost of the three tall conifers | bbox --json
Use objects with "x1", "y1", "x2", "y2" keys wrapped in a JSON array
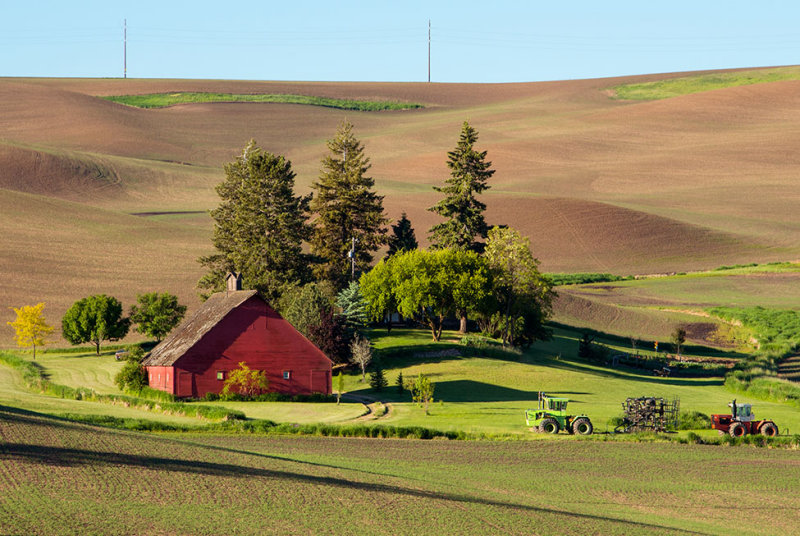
[{"x1": 428, "y1": 121, "x2": 494, "y2": 252}]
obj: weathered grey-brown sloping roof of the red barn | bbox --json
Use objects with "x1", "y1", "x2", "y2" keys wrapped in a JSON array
[{"x1": 142, "y1": 290, "x2": 257, "y2": 367}]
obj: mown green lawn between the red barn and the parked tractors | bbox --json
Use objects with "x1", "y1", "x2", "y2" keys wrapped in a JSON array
[{"x1": 362, "y1": 329, "x2": 800, "y2": 437}]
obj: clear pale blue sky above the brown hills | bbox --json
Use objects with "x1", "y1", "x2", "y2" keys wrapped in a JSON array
[{"x1": 0, "y1": 0, "x2": 800, "y2": 82}]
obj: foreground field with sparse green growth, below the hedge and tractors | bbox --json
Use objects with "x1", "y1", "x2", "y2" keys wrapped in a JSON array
[{"x1": 0, "y1": 408, "x2": 800, "y2": 535}]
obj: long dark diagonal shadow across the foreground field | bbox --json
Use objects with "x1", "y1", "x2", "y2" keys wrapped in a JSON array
[{"x1": 0, "y1": 443, "x2": 691, "y2": 534}]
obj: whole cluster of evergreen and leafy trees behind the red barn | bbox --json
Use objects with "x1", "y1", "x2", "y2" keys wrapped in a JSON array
[{"x1": 198, "y1": 121, "x2": 553, "y2": 348}]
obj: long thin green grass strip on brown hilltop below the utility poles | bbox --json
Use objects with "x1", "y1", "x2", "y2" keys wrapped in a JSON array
[{"x1": 103, "y1": 92, "x2": 422, "y2": 112}]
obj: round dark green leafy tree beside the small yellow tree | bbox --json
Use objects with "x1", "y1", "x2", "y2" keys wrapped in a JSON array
[{"x1": 61, "y1": 294, "x2": 130, "y2": 355}]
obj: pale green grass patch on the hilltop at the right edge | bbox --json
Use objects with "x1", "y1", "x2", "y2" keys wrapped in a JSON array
[{"x1": 613, "y1": 67, "x2": 800, "y2": 100}]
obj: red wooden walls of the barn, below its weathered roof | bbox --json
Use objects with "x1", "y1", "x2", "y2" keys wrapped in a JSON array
[{"x1": 173, "y1": 296, "x2": 331, "y2": 397}]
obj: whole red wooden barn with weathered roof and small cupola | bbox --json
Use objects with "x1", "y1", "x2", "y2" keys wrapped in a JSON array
[{"x1": 143, "y1": 275, "x2": 332, "y2": 398}]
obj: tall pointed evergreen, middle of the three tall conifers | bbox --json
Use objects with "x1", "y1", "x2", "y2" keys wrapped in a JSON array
[{"x1": 311, "y1": 122, "x2": 389, "y2": 289}]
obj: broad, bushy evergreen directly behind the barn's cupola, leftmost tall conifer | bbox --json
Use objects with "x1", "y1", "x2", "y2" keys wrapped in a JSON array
[{"x1": 198, "y1": 140, "x2": 311, "y2": 301}]
